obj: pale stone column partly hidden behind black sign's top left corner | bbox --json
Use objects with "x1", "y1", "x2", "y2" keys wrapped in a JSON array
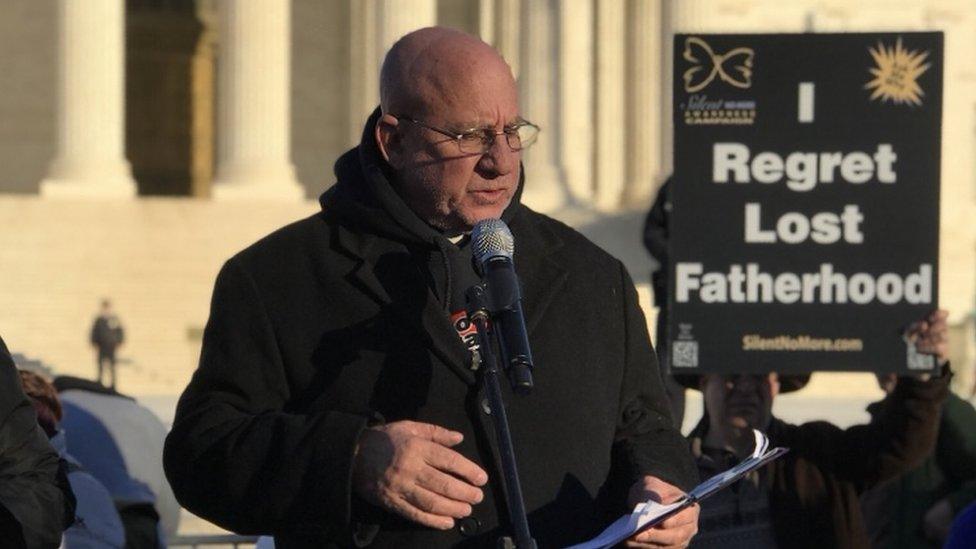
[{"x1": 661, "y1": 0, "x2": 709, "y2": 175}]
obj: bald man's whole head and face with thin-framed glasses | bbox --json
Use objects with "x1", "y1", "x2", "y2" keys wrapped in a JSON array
[{"x1": 373, "y1": 27, "x2": 522, "y2": 234}]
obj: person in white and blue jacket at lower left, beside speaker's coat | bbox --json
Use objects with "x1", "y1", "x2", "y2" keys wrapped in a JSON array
[{"x1": 54, "y1": 376, "x2": 180, "y2": 549}]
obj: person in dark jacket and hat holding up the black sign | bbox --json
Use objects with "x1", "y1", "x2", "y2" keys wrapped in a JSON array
[{"x1": 677, "y1": 310, "x2": 951, "y2": 549}]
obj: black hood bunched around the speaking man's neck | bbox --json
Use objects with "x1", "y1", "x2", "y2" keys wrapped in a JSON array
[{"x1": 319, "y1": 107, "x2": 525, "y2": 247}]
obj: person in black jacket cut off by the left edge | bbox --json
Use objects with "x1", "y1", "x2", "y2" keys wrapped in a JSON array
[{"x1": 0, "y1": 338, "x2": 75, "y2": 549}]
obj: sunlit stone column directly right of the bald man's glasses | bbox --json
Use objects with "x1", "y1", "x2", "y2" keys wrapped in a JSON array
[{"x1": 519, "y1": 0, "x2": 567, "y2": 212}]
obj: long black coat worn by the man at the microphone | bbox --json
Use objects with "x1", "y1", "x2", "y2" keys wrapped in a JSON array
[{"x1": 164, "y1": 113, "x2": 696, "y2": 548}]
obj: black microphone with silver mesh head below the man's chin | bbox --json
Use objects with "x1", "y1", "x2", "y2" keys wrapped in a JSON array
[{"x1": 471, "y1": 219, "x2": 533, "y2": 395}]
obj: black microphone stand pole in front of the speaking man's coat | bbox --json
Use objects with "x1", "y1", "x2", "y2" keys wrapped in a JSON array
[{"x1": 467, "y1": 284, "x2": 538, "y2": 549}]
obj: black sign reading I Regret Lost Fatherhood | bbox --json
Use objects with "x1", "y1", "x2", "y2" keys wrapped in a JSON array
[{"x1": 668, "y1": 32, "x2": 943, "y2": 373}]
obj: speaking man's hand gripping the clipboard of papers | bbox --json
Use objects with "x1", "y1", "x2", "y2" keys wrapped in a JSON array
[{"x1": 625, "y1": 475, "x2": 698, "y2": 549}]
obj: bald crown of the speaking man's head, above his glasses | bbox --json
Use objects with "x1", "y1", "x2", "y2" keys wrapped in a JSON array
[{"x1": 380, "y1": 27, "x2": 515, "y2": 116}]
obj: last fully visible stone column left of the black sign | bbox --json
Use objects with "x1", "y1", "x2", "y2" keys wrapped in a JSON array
[{"x1": 623, "y1": 0, "x2": 665, "y2": 207}]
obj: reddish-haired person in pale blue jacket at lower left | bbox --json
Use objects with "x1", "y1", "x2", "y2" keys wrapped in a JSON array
[{"x1": 20, "y1": 370, "x2": 125, "y2": 549}]
